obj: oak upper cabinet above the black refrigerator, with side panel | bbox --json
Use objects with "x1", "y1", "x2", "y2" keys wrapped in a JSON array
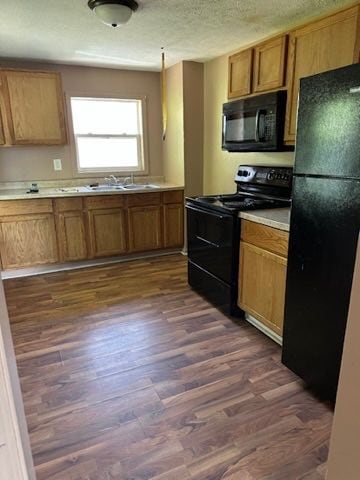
[{"x1": 285, "y1": 7, "x2": 360, "y2": 142}]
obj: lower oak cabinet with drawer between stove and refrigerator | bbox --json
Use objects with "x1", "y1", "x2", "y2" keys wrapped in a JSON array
[{"x1": 238, "y1": 221, "x2": 288, "y2": 337}]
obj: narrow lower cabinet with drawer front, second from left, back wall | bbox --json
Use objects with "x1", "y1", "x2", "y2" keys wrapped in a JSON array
[{"x1": 54, "y1": 198, "x2": 88, "y2": 262}]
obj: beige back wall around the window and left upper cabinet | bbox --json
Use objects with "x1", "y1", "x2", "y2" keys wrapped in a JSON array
[{"x1": 0, "y1": 61, "x2": 163, "y2": 182}]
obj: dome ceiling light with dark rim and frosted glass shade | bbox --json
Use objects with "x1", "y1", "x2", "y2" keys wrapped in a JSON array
[{"x1": 88, "y1": 0, "x2": 139, "y2": 27}]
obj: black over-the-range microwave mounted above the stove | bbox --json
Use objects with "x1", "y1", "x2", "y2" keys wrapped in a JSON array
[{"x1": 222, "y1": 90, "x2": 294, "y2": 152}]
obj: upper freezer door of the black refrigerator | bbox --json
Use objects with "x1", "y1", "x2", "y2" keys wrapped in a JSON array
[{"x1": 295, "y1": 64, "x2": 360, "y2": 178}]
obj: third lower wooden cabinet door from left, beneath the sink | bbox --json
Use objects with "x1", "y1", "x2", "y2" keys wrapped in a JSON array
[{"x1": 89, "y1": 208, "x2": 127, "y2": 257}]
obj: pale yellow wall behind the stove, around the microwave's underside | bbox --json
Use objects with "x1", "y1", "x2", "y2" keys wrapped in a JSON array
[{"x1": 204, "y1": 55, "x2": 294, "y2": 195}]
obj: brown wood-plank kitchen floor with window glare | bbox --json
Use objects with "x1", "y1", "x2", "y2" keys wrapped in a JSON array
[{"x1": 5, "y1": 255, "x2": 332, "y2": 480}]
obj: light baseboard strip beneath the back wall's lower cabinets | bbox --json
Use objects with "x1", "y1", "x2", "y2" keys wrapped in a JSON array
[{"x1": 1, "y1": 249, "x2": 182, "y2": 280}]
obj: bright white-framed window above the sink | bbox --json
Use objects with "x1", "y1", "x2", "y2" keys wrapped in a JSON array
[{"x1": 70, "y1": 97, "x2": 145, "y2": 173}]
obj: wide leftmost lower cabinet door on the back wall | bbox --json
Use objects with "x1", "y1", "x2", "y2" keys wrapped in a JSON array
[{"x1": 0, "y1": 214, "x2": 58, "y2": 269}]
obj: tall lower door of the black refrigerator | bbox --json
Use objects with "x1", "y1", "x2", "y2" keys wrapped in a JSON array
[{"x1": 283, "y1": 177, "x2": 360, "y2": 399}]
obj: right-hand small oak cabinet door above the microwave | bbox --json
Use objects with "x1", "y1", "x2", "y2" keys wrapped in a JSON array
[{"x1": 254, "y1": 35, "x2": 287, "y2": 92}]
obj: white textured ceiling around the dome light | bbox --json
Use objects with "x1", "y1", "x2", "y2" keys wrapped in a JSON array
[{"x1": 0, "y1": 0, "x2": 352, "y2": 70}]
